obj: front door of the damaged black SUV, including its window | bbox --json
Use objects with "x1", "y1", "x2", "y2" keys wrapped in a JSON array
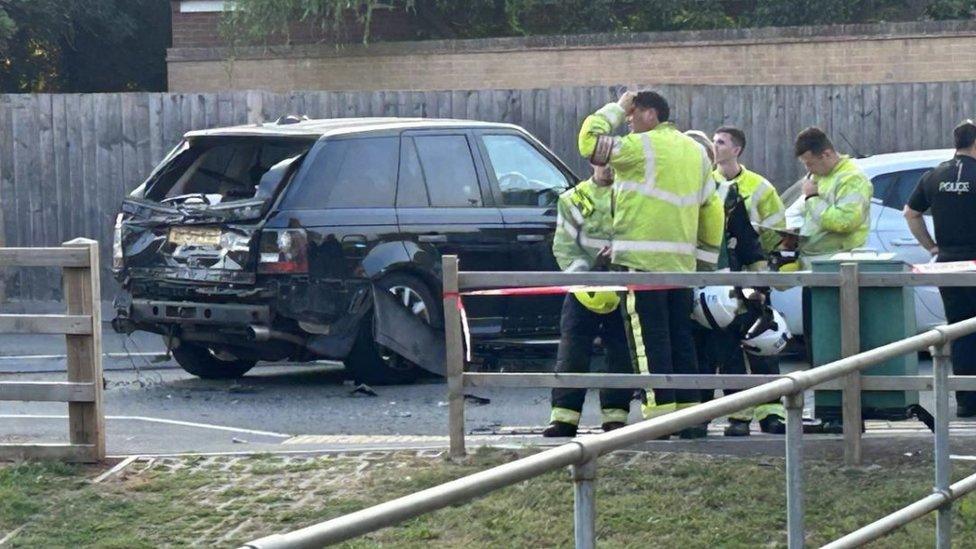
[{"x1": 478, "y1": 130, "x2": 576, "y2": 335}]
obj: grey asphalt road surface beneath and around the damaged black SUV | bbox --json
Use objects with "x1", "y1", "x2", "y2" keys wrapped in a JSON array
[{"x1": 0, "y1": 340, "x2": 976, "y2": 455}]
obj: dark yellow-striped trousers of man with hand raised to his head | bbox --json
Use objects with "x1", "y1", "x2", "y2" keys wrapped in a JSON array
[{"x1": 622, "y1": 288, "x2": 701, "y2": 412}]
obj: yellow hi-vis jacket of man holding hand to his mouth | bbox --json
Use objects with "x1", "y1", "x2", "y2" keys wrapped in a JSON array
[{"x1": 800, "y1": 155, "x2": 874, "y2": 257}]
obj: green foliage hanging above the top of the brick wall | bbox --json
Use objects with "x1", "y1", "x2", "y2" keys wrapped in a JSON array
[{"x1": 223, "y1": 0, "x2": 976, "y2": 44}]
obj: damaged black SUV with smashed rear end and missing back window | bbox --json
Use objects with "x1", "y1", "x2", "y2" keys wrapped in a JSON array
[{"x1": 113, "y1": 117, "x2": 576, "y2": 383}]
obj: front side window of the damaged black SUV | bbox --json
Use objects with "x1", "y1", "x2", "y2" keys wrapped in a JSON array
[{"x1": 482, "y1": 134, "x2": 570, "y2": 207}]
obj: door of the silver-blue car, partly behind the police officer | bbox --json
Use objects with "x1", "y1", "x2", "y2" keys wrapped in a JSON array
[{"x1": 871, "y1": 168, "x2": 945, "y2": 328}]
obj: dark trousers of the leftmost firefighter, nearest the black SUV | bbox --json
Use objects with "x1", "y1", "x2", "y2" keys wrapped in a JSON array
[{"x1": 552, "y1": 294, "x2": 634, "y2": 421}]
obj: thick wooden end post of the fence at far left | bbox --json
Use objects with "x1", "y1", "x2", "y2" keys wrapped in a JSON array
[{"x1": 63, "y1": 238, "x2": 105, "y2": 461}]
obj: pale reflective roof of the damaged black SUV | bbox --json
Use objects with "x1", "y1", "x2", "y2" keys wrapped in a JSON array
[{"x1": 179, "y1": 117, "x2": 522, "y2": 138}]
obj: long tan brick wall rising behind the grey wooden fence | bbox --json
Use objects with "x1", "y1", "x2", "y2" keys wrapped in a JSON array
[{"x1": 168, "y1": 21, "x2": 976, "y2": 92}]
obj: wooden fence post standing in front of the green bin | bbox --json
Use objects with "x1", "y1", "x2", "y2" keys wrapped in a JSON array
[{"x1": 839, "y1": 263, "x2": 862, "y2": 465}]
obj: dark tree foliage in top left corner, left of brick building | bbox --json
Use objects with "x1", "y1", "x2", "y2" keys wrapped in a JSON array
[{"x1": 0, "y1": 0, "x2": 171, "y2": 92}]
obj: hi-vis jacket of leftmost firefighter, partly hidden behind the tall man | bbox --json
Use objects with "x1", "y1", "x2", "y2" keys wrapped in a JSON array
[{"x1": 552, "y1": 179, "x2": 613, "y2": 272}]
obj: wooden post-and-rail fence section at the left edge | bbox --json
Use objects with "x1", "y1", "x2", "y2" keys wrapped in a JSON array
[{"x1": 0, "y1": 238, "x2": 105, "y2": 462}]
